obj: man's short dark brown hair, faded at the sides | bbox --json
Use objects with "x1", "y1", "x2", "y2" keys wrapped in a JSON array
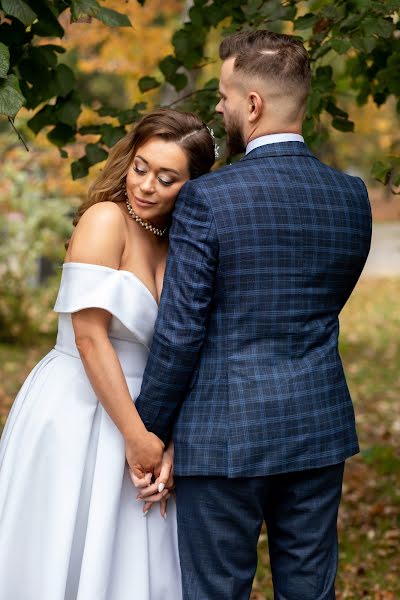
[{"x1": 219, "y1": 29, "x2": 311, "y2": 102}]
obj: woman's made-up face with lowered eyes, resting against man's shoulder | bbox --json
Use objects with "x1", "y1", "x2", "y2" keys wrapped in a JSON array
[{"x1": 126, "y1": 137, "x2": 189, "y2": 227}]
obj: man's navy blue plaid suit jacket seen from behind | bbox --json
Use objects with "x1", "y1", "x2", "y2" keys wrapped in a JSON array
[{"x1": 136, "y1": 142, "x2": 371, "y2": 477}]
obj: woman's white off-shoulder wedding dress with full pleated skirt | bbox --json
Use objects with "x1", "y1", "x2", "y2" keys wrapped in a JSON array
[{"x1": 0, "y1": 263, "x2": 181, "y2": 600}]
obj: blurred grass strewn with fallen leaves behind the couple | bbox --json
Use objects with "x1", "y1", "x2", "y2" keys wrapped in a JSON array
[{"x1": 0, "y1": 279, "x2": 400, "y2": 600}]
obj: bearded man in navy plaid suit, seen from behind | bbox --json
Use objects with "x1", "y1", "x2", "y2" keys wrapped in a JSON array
[{"x1": 136, "y1": 31, "x2": 371, "y2": 600}]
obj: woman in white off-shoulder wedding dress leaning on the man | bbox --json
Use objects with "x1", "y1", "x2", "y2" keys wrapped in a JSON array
[{"x1": 0, "y1": 109, "x2": 214, "y2": 600}]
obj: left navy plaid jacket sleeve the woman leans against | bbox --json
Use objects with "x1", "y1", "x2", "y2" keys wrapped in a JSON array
[{"x1": 136, "y1": 181, "x2": 219, "y2": 442}]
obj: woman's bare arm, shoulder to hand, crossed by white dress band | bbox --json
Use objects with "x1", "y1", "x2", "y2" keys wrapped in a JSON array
[{"x1": 66, "y1": 202, "x2": 163, "y2": 477}]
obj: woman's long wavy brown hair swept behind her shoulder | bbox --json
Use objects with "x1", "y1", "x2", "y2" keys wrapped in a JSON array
[{"x1": 73, "y1": 108, "x2": 215, "y2": 225}]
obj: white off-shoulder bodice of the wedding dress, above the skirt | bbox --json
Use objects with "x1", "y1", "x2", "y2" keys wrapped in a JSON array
[{"x1": 54, "y1": 262, "x2": 158, "y2": 376}]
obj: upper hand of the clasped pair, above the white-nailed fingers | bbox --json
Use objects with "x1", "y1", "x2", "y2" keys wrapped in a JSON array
[{"x1": 125, "y1": 431, "x2": 164, "y2": 478}]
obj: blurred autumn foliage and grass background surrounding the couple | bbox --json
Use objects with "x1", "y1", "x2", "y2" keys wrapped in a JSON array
[{"x1": 0, "y1": 0, "x2": 400, "y2": 600}]
